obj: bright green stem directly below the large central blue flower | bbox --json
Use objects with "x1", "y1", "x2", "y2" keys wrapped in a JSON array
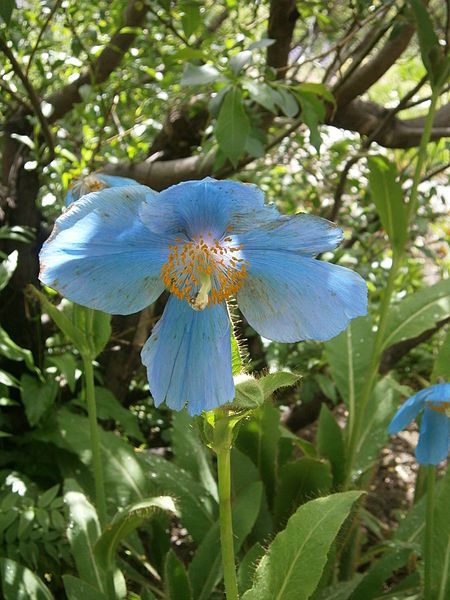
[{"x1": 217, "y1": 447, "x2": 239, "y2": 600}]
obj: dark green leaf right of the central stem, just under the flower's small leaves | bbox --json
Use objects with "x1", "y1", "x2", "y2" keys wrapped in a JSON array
[{"x1": 236, "y1": 404, "x2": 280, "y2": 505}]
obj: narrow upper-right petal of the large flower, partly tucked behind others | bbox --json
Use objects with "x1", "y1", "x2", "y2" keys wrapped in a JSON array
[{"x1": 238, "y1": 214, "x2": 343, "y2": 256}]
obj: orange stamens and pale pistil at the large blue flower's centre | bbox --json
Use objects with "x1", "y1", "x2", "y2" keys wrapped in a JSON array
[{"x1": 161, "y1": 230, "x2": 248, "y2": 310}]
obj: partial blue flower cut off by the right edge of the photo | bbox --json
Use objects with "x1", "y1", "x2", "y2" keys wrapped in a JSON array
[{"x1": 388, "y1": 383, "x2": 450, "y2": 465}]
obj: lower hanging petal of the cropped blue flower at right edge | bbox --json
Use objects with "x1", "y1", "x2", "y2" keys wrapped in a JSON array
[{"x1": 416, "y1": 406, "x2": 450, "y2": 465}]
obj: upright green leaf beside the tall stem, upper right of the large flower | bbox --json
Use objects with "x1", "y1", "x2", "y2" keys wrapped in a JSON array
[{"x1": 367, "y1": 156, "x2": 408, "y2": 253}]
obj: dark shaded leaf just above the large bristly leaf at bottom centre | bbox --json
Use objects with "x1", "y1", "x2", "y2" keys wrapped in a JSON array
[{"x1": 274, "y1": 457, "x2": 333, "y2": 528}]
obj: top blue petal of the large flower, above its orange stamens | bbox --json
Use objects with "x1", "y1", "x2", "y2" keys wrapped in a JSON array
[{"x1": 142, "y1": 177, "x2": 278, "y2": 238}]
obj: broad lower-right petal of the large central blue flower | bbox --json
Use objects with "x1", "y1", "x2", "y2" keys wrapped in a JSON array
[{"x1": 237, "y1": 248, "x2": 367, "y2": 342}]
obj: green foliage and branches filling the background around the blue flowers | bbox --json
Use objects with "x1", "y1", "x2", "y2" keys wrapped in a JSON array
[{"x1": 0, "y1": 0, "x2": 450, "y2": 600}]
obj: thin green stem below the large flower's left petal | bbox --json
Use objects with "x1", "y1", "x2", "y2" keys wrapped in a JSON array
[{"x1": 82, "y1": 355, "x2": 106, "y2": 528}]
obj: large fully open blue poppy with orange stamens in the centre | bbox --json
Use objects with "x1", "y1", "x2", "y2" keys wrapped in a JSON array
[{"x1": 40, "y1": 178, "x2": 367, "y2": 414}]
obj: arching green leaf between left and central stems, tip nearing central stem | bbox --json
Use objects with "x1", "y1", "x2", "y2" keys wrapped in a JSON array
[{"x1": 145, "y1": 454, "x2": 218, "y2": 543}]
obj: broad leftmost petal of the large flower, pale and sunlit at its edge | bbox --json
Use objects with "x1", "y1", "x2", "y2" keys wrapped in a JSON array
[{"x1": 40, "y1": 185, "x2": 169, "y2": 314}]
